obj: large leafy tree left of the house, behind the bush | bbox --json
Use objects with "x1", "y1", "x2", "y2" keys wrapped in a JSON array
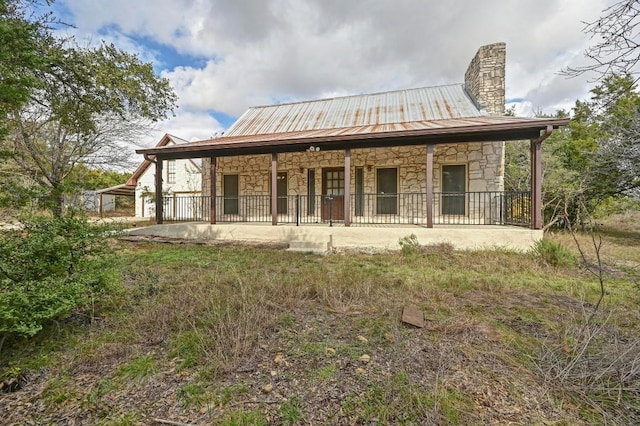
[{"x1": 0, "y1": 0, "x2": 177, "y2": 214}]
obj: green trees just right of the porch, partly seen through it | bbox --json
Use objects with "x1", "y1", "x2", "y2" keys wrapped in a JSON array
[{"x1": 505, "y1": 74, "x2": 640, "y2": 227}]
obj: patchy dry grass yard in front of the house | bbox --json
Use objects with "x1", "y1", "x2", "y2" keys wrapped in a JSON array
[{"x1": 0, "y1": 223, "x2": 640, "y2": 425}]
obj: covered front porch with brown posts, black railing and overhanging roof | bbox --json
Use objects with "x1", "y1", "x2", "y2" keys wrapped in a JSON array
[{"x1": 138, "y1": 116, "x2": 568, "y2": 230}]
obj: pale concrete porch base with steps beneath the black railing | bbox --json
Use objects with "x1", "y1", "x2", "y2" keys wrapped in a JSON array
[{"x1": 127, "y1": 222, "x2": 542, "y2": 251}]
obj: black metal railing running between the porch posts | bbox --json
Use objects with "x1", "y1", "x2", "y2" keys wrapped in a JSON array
[{"x1": 163, "y1": 191, "x2": 531, "y2": 226}]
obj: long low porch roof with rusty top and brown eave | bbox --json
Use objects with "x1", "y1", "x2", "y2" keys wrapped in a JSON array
[{"x1": 136, "y1": 116, "x2": 569, "y2": 159}]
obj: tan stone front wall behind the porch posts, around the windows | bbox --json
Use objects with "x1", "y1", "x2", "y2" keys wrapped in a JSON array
[{"x1": 203, "y1": 142, "x2": 503, "y2": 222}]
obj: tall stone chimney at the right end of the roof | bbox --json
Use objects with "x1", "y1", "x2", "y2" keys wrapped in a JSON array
[{"x1": 464, "y1": 43, "x2": 507, "y2": 115}]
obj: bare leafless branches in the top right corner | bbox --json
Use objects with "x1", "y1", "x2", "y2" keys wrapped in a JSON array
[{"x1": 563, "y1": 0, "x2": 640, "y2": 81}]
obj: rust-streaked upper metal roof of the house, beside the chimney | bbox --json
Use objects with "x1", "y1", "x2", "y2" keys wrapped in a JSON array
[{"x1": 224, "y1": 84, "x2": 480, "y2": 139}]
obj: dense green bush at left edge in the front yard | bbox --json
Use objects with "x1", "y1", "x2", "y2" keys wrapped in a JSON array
[{"x1": 0, "y1": 215, "x2": 119, "y2": 350}]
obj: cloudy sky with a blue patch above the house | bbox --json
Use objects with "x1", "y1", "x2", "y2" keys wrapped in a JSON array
[{"x1": 54, "y1": 0, "x2": 612, "y2": 146}]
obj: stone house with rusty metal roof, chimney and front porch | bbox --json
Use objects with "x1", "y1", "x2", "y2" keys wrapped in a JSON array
[{"x1": 138, "y1": 43, "x2": 568, "y2": 229}]
